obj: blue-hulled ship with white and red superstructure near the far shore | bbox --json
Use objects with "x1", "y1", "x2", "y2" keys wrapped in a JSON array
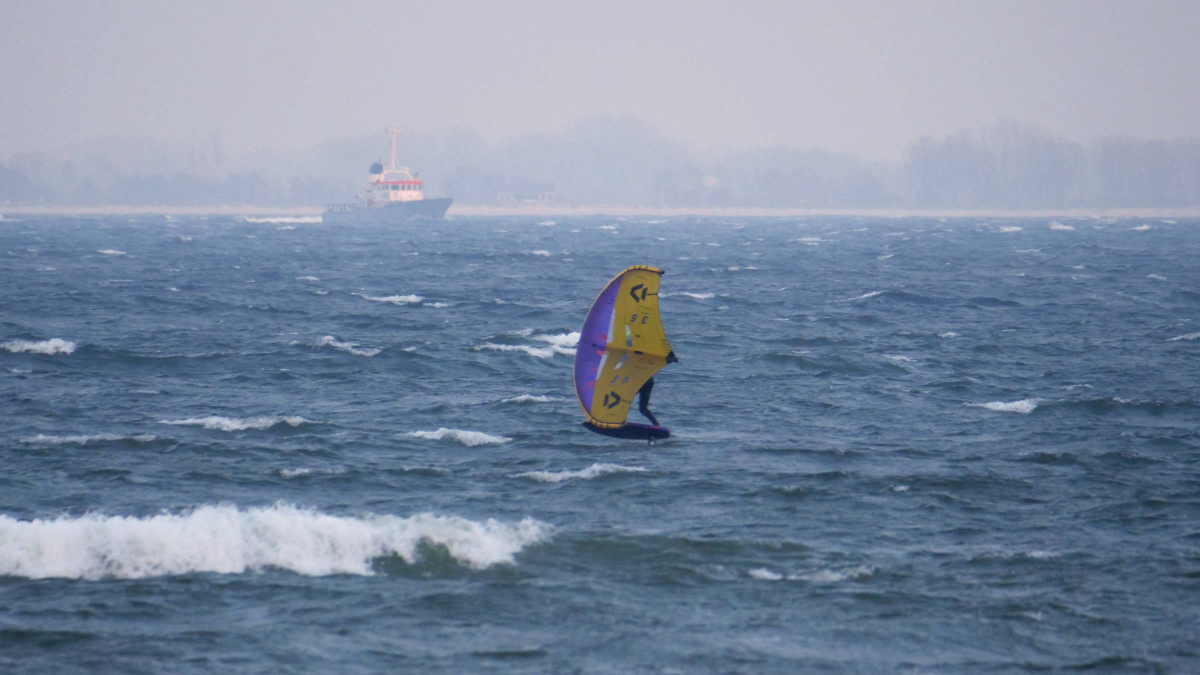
[{"x1": 320, "y1": 126, "x2": 454, "y2": 223}]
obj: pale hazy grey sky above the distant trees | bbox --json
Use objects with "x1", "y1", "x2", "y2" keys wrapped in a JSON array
[{"x1": 7, "y1": 0, "x2": 1200, "y2": 159}]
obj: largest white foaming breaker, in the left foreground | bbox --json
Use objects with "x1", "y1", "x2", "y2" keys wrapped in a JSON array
[{"x1": 0, "y1": 503, "x2": 551, "y2": 579}]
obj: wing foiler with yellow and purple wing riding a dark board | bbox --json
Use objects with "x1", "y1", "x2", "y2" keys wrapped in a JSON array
[{"x1": 575, "y1": 265, "x2": 671, "y2": 440}]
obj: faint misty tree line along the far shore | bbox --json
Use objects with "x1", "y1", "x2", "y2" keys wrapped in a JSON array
[{"x1": 0, "y1": 118, "x2": 1200, "y2": 209}]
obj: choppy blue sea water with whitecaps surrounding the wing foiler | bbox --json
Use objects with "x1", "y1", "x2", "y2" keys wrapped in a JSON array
[{"x1": 0, "y1": 216, "x2": 1200, "y2": 674}]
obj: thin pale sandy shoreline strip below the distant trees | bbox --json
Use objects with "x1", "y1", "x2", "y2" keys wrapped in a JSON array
[{"x1": 0, "y1": 204, "x2": 1200, "y2": 220}]
